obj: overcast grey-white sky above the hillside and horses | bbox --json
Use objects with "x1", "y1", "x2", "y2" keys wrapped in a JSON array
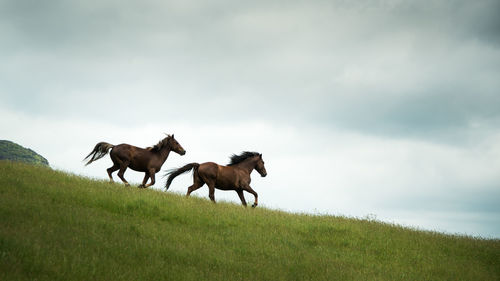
[{"x1": 0, "y1": 0, "x2": 500, "y2": 238}]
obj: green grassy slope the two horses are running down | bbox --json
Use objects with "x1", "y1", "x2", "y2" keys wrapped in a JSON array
[{"x1": 0, "y1": 161, "x2": 500, "y2": 280}]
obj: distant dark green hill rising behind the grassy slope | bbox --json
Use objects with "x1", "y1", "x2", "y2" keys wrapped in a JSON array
[{"x1": 0, "y1": 140, "x2": 49, "y2": 166}]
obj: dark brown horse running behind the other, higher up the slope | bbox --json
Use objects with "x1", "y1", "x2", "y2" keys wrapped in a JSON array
[{"x1": 83, "y1": 135, "x2": 186, "y2": 188}]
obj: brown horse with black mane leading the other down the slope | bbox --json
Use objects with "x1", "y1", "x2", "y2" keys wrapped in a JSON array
[{"x1": 165, "y1": 151, "x2": 267, "y2": 207}]
